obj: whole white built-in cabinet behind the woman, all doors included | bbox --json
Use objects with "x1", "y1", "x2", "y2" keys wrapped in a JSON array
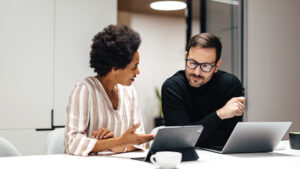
[{"x1": 0, "y1": 0, "x2": 117, "y2": 155}]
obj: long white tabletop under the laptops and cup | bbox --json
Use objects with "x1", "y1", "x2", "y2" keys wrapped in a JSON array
[{"x1": 0, "y1": 141, "x2": 300, "y2": 169}]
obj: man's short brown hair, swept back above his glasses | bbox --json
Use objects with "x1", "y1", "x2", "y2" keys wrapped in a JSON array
[{"x1": 187, "y1": 33, "x2": 222, "y2": 62}]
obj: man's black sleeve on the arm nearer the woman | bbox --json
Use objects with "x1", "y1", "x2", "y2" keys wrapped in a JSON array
[{"x1": 162, "y1": 79, "x2": 222, "y2": 143}]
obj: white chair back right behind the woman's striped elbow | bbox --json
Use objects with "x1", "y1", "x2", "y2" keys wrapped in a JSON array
[{"x1": 45, "y1": 128, "x2": 65, "y2": 154}]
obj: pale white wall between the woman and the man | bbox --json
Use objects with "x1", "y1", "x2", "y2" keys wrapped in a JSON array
[{"x1": 119, "y1": 13, "x2": 186, "y2": 132}]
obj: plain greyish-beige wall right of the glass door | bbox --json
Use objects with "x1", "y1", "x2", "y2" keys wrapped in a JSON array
[{"x1": 245, "y1": 0, "x2": 300, "y2": 135}]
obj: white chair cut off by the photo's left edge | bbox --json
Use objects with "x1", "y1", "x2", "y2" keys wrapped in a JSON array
[{"x1": 0, "y1": 137, "x2": 21, "y2": 157}]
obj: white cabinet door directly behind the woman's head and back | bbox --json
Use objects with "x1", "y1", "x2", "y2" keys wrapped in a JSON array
[{"x1": 54, "y1": 0, "x2": 117, "y2": 125}]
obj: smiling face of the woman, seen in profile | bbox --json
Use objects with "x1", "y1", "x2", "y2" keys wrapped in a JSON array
[{"x1": 115, "y1": 51, "x2": 140, "y2": 86}]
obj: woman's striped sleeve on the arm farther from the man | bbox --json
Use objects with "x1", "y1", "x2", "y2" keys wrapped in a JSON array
[{"x1": 65, "y1": 83, "x2": 97, "y2": 156}]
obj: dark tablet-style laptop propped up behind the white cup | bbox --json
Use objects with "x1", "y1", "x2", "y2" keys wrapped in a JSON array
[{"x1": 132, "y1": 125, "x2": 203, "y2": 162}]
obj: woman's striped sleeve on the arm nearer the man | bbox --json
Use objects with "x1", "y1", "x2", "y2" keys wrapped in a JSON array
[{"x1": 131, "y1": 87, "x2": 146, "y2": 150}]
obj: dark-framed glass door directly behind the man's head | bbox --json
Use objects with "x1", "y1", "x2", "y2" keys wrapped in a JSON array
[{"x1": 186, "y1": 0, "x2": 244, "y2": 83}]
